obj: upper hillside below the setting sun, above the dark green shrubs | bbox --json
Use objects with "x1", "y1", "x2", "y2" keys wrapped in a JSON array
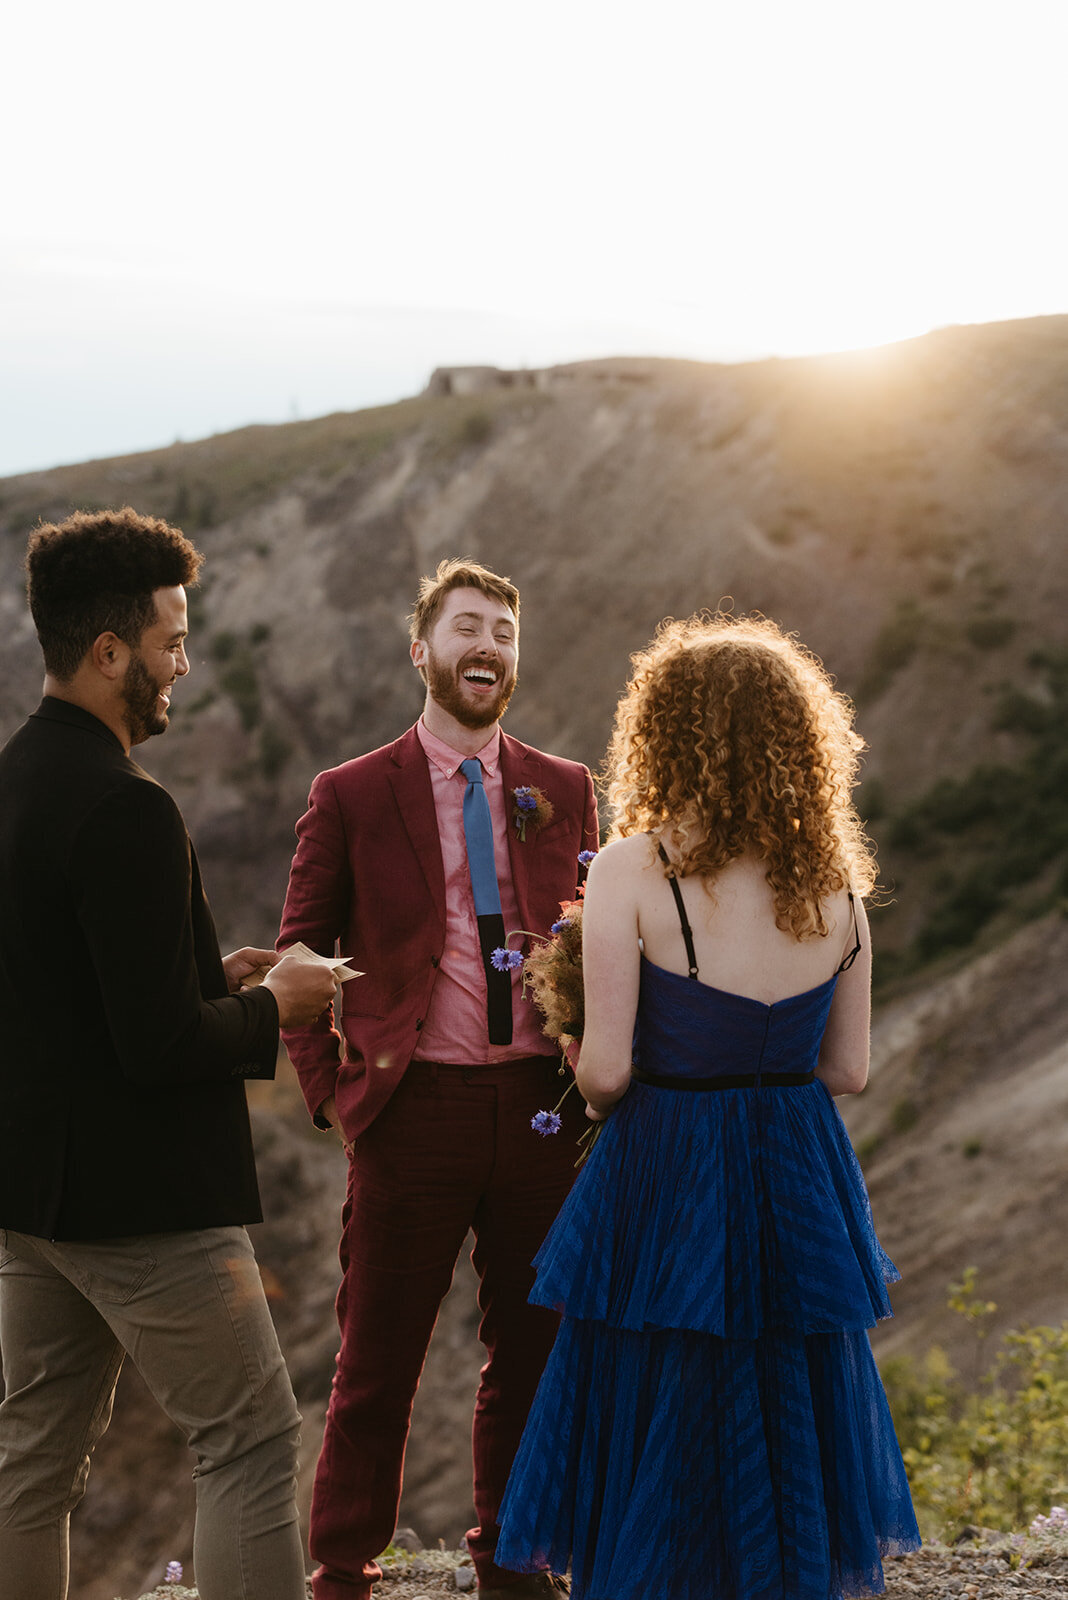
[{"x1": 0, "y1": 318, "x2": 1068, "y2": 971}]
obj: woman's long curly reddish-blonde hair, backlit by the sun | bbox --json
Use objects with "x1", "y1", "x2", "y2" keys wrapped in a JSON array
[{"x1": 604, "y1": 613, "x2": 876, "y2": 939}]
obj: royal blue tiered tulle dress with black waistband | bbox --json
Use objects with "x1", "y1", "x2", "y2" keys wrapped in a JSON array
[{"x1": 496, "y1": 883, "x2": 919, "y2": 1600}]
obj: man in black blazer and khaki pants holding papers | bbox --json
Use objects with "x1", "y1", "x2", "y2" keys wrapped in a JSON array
[{"x1": 0, "y1": 509, "x2": 334, "y2": 1600}]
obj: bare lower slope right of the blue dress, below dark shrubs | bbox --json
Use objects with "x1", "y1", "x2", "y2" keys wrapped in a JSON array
[{"x1": 839, "y1": 912, "x2": 1068, "y2": 1373}]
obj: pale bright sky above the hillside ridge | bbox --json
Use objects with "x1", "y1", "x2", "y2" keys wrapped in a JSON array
[{"x1": 0, "y1": 0, "x2": 1068, "y2": 475}]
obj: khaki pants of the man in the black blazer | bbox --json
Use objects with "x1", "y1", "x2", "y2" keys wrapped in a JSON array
[{"x1": 0, "y1": 1227, "x2": 304, "y2": 1600}]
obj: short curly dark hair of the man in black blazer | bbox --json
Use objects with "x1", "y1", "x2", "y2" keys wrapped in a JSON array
[{"x1": 26, "y1": 506, "x2": 203, "y2": 683}]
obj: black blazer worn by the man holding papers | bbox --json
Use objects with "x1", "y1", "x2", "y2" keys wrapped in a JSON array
[{"x1": 0, "y1": 698, "x2": 278, "y2": 1238}]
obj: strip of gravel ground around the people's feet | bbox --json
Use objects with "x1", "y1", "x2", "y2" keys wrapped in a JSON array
[{"x1": 133, "y1": 1534, "x2": 1068, "y2": 1600}]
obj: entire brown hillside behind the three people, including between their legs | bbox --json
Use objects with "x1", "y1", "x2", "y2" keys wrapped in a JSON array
[{"x1": 0, "y1": 318, "x2": 1068, "y2": 1600}]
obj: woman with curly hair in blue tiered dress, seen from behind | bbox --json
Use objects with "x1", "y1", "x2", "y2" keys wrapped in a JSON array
[{"x1": 496, "y1": 616, "x2": 919, "y2": 1600}]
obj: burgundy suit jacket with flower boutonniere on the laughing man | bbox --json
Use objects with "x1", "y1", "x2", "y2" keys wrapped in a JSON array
[{"x1": 278, "y1": 728, "x2": 598, "y2": 1139}]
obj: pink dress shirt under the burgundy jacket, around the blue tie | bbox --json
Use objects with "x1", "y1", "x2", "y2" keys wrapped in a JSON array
[{"x1": 412, "y1": 717, "x2": 556, "y2": 1067}]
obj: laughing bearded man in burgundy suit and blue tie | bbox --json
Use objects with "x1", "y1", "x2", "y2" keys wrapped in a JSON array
[{"x1": 280, "y1": 562, "x2": 598, "y2": 1600}]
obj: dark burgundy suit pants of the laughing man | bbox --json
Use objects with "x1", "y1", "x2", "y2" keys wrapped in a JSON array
[{"x1": 310, "y1": 1056, "x2": 585, "y2": 1600}]
